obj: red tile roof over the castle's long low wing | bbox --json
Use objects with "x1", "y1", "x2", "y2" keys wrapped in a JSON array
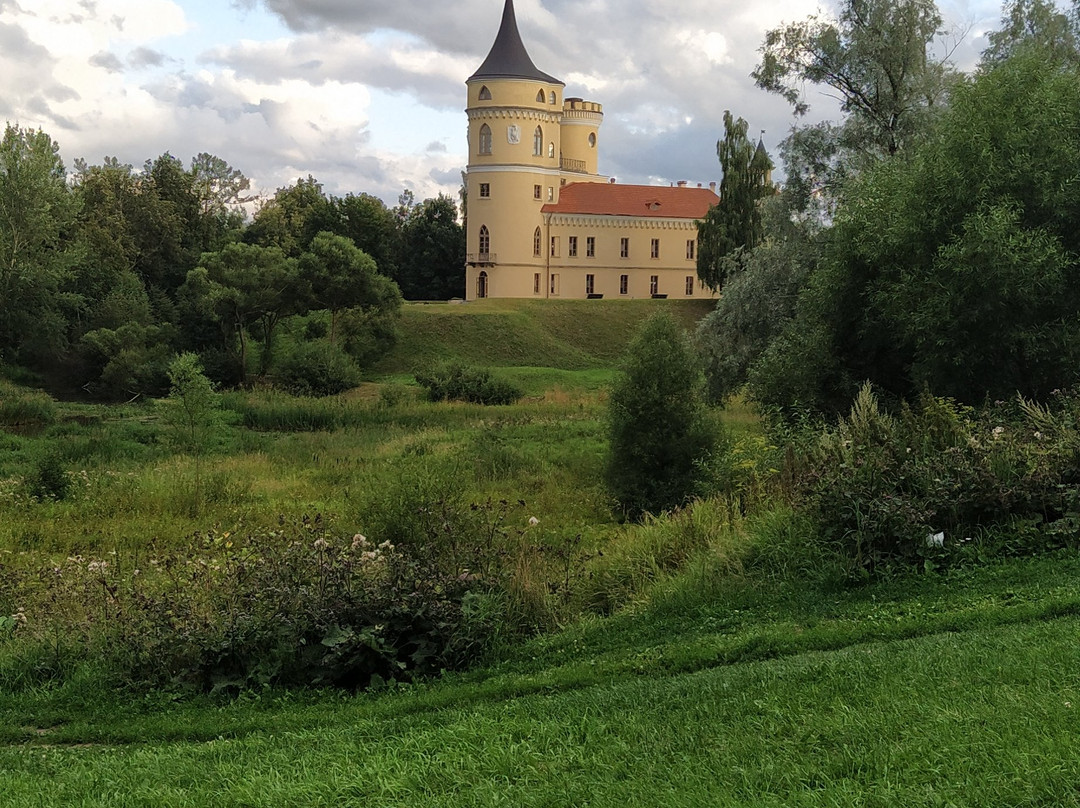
[{"x1": 543, "y1": 183, "x2": 720, "y2": 219}]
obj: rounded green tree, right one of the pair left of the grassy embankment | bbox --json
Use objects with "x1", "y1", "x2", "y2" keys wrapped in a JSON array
[{"x1": 299, "y1": 232, "x2": 401, "y2": 344}]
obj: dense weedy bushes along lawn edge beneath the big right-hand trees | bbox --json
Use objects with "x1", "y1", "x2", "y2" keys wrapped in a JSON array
[{"x1": 802, "y1": 386, "x2": 1080, "y2": 575}]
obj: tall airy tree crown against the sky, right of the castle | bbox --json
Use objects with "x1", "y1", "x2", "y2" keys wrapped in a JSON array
[{"x1": 752, "y1": 0, "x2": 954, "y2": 158}]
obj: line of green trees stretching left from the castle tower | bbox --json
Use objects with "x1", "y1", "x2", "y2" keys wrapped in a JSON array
[{"x1": 0, "y1": 139, "x2": 465, "y2": 400}]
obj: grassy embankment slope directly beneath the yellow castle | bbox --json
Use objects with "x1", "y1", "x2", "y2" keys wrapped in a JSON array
[{"x1": 375, "y1": 300, "x2": 715, "y2": 374}]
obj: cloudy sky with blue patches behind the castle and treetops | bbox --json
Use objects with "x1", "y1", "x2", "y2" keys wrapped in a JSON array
[{"x1": 0, "y1": 0, "x2": 1001, "y2": 204}]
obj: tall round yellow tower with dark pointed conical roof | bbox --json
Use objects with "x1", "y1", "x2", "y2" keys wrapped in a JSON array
[{"x1": 465, "y1": 0, "x2": 565, "y2": 300}]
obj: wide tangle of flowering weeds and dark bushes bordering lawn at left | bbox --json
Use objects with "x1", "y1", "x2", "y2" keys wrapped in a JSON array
[{"x1": 0, "y1": 519, "x2": 505, "y2": 692}]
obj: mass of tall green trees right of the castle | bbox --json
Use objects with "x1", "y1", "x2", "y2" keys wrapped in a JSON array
[{"x1": 698, "y1": 0, "x2": 1080, "y2": 415}]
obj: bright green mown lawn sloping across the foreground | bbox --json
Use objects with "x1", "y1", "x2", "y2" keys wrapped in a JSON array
[{"x1": 0, "y1": 557, "x2": 1080, "y2": 808}]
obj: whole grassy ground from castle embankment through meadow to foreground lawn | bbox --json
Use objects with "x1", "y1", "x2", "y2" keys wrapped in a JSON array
[{"x1": 0, "y1": 301, "x2": 1080, "y2": 808}]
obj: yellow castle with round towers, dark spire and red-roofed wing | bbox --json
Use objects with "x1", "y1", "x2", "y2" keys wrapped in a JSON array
[{"x1": 465, "y1": 0, "x2": 719, "y2": 300}]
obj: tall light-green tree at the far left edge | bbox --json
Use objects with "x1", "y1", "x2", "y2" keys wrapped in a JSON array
[{"x1": 0, "y1": 125, "x2": 78, "y2": 360}]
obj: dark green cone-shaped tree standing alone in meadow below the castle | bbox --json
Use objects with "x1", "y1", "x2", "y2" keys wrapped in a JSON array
[{"x1": 607, "y1": 312, "x2": 718, "y2": 519}]
